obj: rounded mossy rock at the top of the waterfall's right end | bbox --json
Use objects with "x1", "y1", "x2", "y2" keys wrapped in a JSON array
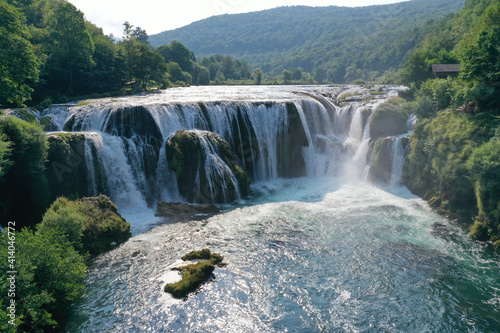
[{"x1": 370, "y1": 103, "x2": 409, "y2": 139}]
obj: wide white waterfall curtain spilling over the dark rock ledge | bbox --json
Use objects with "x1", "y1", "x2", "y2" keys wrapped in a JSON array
[{"x1": 43, "y1": 88, "x2": 415, "y2": 208}]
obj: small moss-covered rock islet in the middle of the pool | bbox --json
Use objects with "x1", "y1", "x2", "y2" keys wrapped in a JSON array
[{"x1": 164, "y1": 249, "x2": 224, "y2": 298}]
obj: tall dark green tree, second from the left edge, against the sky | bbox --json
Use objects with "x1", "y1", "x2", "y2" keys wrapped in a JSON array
[{"x1": 44, "y1": 2, "x2": 95, "y2": 95}]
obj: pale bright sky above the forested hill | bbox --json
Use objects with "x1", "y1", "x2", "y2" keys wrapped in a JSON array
[{"x1": 68, "y1": 0, "x2": 408, "y2": 37}]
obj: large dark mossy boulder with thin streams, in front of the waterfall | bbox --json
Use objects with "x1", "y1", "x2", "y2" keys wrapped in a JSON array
[{"x1": 165, "y1": 130, "x2": 252, "y2": 203}]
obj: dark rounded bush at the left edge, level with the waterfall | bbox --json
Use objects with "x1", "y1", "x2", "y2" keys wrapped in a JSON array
[{"x1": 0, "y1": 116, "x2": 48, "y2": 226}]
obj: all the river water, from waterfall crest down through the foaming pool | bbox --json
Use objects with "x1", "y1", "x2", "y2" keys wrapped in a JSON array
[{"x1": 46, "y1": 87, "x2": 500, "y2": 333}]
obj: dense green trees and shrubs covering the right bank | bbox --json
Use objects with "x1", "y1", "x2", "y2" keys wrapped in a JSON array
[{"x1": 399, "y1": 0, "x2": 500, "y2": 248}]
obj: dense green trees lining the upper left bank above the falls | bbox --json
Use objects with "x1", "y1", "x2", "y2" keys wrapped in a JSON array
[{"x1": 0, "y1": 0, "x2": 251, "y2": 107}]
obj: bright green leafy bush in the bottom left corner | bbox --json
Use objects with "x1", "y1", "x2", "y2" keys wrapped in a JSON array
[{"x1": 0, "y1": 229, "x2": 86, "y2": 333}]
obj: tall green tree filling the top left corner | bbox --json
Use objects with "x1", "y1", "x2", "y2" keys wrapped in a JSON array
[{"x1": 0, "y1": 0, "x2": 39, "y2": 106}]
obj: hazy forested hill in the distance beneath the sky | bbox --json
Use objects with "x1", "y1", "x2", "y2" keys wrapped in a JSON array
[{"x1": 149, "y1": 0, "x2": 464, "y2": 82}]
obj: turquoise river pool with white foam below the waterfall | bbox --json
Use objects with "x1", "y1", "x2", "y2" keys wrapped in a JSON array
[{"x1": 67, "y1": 178, "x2": 500, "y2": 332}]
